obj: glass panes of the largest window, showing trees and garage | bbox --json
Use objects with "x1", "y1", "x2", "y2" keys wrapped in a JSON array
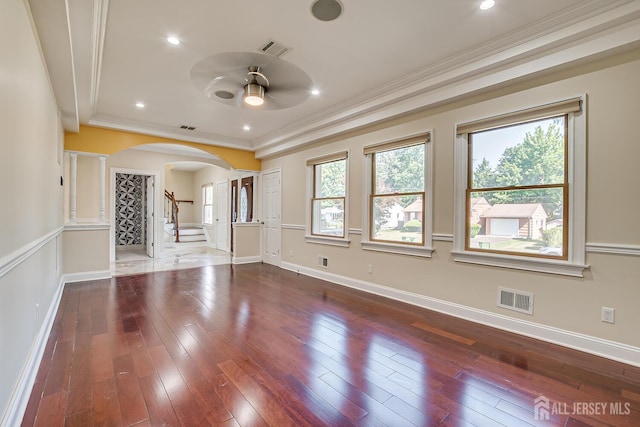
[{"x1": 466, "y1": 115, "x2": 569, "y2": 259}]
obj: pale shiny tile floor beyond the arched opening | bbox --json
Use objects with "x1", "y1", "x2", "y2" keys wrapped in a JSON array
[{"x1": 111, "y1": 243, "x2": 231, "y2": 276}]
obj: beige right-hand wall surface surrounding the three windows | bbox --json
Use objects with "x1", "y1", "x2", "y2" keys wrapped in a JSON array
[{"x1": 263, "y1": 50, "x2": 640, "y2": 350}]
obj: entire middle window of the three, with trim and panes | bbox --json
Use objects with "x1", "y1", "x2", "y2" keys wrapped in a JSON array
[{"x1": 363, "y1": 133, "x2": 432, "y2": 256}]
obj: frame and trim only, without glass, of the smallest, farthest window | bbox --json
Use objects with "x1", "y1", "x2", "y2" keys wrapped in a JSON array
[{"x1": 305, "y1": 150, "x2": 350, "y2": 247}]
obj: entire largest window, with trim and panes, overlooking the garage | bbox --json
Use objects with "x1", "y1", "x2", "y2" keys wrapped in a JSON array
[{"x1": 454, "y1": 98, "x2": 585, "y2": 275}]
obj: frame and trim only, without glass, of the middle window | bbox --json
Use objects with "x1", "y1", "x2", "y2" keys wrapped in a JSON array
[{"x1": 361, "y1": 130, "x2": 434, "y2": 258}]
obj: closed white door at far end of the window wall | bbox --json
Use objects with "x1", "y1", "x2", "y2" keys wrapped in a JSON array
[{"x1": 262, "y1": 171, "x2": 282, "y2": 266}]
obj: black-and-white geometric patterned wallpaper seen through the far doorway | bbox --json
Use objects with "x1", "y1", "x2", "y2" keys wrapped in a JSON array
[{"x1": 116, "y1": 173, "x2": 147, "y2": 245}]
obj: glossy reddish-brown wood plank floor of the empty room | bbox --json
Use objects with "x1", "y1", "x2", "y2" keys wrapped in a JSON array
[{"x1": 23, "y1": 264, "x2": 640, "y2": 427}]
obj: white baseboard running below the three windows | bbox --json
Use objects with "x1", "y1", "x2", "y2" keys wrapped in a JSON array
[{"x1": 281, "y1": 262, "x2": 640, "y2": 367}]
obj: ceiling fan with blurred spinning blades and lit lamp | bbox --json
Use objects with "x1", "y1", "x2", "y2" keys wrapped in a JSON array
[{"x1": 191, "y1": 52, "x2": 312, "y2": 110}]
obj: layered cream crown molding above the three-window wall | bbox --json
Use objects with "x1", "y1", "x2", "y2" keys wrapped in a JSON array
[{"x1": 254, "y1": 0, "x2": 640, "y2": 159}]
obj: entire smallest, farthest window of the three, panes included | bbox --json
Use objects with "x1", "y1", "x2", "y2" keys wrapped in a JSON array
[{"x1": 307, "y1": 151, "x2": 348, "y2": 245}]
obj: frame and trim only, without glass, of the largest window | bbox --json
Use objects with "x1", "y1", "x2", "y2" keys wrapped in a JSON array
[{"x1": 452, "y1": 95, "x2": 588, "y2": 277}]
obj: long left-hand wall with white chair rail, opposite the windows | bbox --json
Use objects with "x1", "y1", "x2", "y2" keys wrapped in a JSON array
[{"x1": 0, "y1": 0, "x2": 63, "y2": 425}]
